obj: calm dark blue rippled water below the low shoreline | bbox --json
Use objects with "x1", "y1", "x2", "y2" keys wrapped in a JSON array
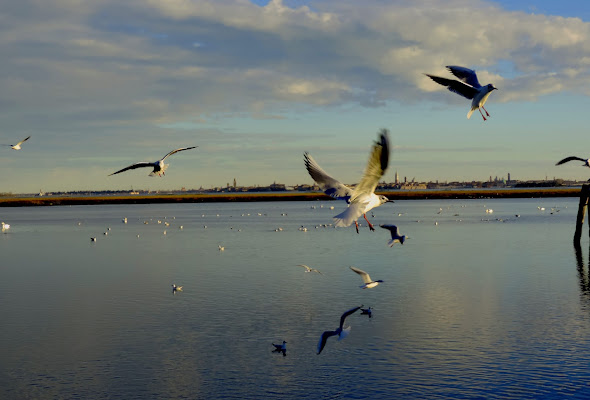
[{"x1": 0, "y1": 199, "x2": 590, "y2": 399}]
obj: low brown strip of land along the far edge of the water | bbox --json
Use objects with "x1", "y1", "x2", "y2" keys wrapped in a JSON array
[{"x1": 0, "y1": 188, "x2": 581, "y2": 207}]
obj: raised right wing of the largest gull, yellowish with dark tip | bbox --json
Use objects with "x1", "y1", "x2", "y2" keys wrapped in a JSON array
[{"x1": 350, "y1": 129, "x2": 389, "y2": 203}]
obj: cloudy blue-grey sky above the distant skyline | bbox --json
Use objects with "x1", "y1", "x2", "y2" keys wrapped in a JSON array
[{"x1": 0, "y1": 0, "x2": 590, "y2": 193}]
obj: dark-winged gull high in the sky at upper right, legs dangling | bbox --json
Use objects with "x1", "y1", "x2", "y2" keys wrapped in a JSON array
[{"x1": 424, "y1": 65, "x2": 498, "y2": 121}]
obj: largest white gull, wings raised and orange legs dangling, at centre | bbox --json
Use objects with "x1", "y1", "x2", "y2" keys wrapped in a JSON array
[{"x1": 304, "y1": 129, "x2": 393, "y2": 233}]
